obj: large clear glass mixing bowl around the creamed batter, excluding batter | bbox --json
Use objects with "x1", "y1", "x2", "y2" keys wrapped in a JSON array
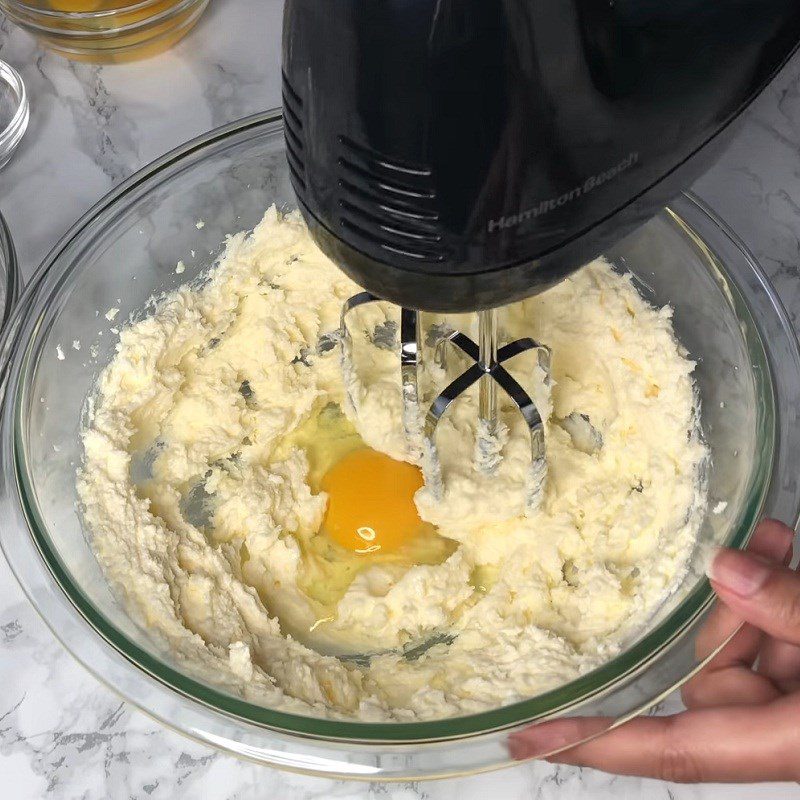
[{"x1": 0, "y1": 112, "x2": 800, "y2": 780}]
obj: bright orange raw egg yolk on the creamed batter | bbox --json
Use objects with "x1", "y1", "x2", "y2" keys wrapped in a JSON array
[{"x1": 321, "y1": 448, "x2": 423, "y2": 555}]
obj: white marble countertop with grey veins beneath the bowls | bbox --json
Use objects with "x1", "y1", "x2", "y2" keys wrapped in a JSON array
[{"x1": 0, "y1": 0, "x2": 800, "y2": 800}]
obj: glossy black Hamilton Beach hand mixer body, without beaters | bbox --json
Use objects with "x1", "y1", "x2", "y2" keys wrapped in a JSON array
[{"x1": 283, "y1": 0, "x2": 800, "y2": 311}]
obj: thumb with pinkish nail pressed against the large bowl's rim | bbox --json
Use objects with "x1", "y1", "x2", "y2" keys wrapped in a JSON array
[{"x1": 708, "y1": 549, "x2": 800, "y2": 644}]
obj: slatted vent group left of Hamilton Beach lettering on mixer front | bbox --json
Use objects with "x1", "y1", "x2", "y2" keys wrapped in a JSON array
[{"x1": 338, "y1": 136, "x2": 448, "y2": 262}]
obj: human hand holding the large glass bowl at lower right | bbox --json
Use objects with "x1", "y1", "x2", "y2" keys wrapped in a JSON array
[{"x1": 509, "y1": 520, "x2": 800, "y2": 783}]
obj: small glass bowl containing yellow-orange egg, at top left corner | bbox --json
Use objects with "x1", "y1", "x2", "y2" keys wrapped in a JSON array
[{"x1": 0, "y1": 0, "x2": 209, "y2": 64}]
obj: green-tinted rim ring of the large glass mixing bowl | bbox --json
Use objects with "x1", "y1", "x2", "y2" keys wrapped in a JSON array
[{"x1": 0, "y1": 111, "x2": 797, "y2": 744}]
